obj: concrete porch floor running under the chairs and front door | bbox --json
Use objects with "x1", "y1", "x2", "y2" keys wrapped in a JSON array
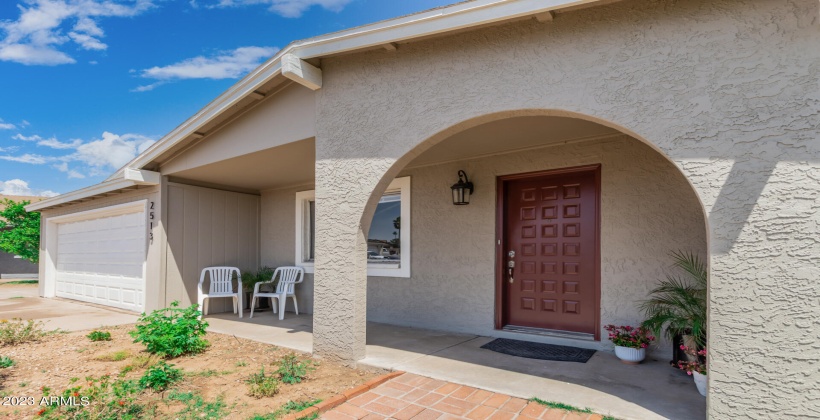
[{"x1": 206, "y1": 312, "x2": 706, "y2": 419}]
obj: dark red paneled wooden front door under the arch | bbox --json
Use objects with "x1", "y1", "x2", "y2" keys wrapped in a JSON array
[{"x1": 498, "y1": 166, "x2": 600, "y2": 338}]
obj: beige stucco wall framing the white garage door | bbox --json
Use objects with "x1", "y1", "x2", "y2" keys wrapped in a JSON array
[{"x1": 38, "y1": 186, "x2": 165, "y2": 311}]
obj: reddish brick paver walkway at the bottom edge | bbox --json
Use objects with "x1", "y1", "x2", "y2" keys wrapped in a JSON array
[{"x1": 322, "y1": 373, "x2": 601, "y2": 420}]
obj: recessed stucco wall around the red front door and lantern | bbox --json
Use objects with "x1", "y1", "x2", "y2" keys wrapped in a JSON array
[{"x1": 367, "y1": 135, "x2": 706, "y2": 357}]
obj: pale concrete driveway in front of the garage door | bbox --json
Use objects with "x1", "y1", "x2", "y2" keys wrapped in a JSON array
[{"x1": 0, "y1": 279, "x2": 137, "y2": 331}]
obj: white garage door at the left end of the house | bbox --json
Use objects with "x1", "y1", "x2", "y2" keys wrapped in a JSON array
[{"x1": 55, "y1": 211, "x2": 146, "y2": 312}]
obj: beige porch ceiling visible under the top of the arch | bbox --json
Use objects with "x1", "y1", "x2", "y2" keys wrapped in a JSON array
[{"x1": 407, "y1": 117, "x2": 620, "y2": 168}]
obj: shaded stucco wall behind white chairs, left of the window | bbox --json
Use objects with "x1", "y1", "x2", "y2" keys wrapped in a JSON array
[{"x1": 260, "y1": 186, "x2": 313, "y2": 314}]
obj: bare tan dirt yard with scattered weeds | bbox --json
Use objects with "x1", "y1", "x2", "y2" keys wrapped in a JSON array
[{"x1": 0, "y1": 325, "x2": 384, "y2": 419}]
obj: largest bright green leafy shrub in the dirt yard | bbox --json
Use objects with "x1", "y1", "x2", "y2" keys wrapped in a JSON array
[{"x1": 129, "y1": 301, "x2": 208, "y2": 358}]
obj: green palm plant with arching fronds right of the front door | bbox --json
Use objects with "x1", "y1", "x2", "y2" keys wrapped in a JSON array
[{"x1": 640, "y1": 251, "x2": 709, "y2": 347}]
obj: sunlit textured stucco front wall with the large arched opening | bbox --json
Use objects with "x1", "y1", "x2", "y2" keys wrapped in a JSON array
[{"x1": 314, "y1": 0, "x2": 820, "y2": 418}]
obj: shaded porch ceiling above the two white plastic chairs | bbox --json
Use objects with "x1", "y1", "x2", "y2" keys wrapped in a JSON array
[{"x1": 167, "y1": 138, "x2": 316, "y2": 191}]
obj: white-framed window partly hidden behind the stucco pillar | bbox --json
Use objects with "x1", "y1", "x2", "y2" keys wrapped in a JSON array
[{"x1": 296, "y1": 177, "x2": 410, "y2": 277}]
